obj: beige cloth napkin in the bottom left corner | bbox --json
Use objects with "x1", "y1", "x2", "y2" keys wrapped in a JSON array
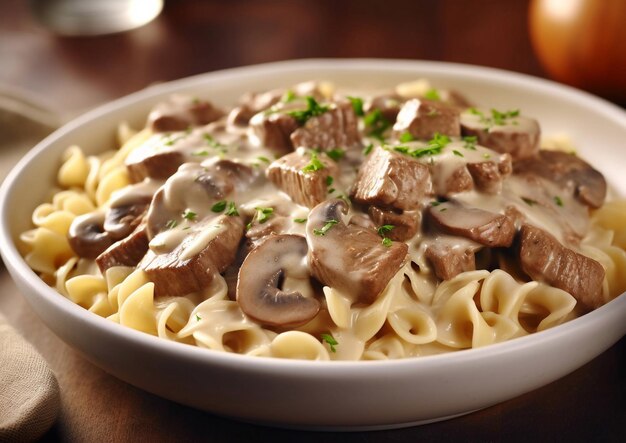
[{"x1": 0, "y1": 316, "x2": 60, "y2": 442}]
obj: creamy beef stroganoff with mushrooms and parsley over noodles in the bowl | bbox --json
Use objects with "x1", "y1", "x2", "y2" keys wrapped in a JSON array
[{"x1": 21, "y1": 80, "x2": 626, "y2": 360}]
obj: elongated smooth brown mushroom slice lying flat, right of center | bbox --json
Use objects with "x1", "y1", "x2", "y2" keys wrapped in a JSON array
[{"x1": 428, "y1": 203, "x2": 515, "y2": 247}]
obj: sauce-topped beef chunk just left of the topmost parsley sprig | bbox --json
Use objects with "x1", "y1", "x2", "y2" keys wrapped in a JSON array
[{"x1": 250, "y1": 112, "x2": 299, "y2": 155}]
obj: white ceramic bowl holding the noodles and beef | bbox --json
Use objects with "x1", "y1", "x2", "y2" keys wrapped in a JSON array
[{"x1": 0, "y1": 60, "x2": 626, "y2": 429}]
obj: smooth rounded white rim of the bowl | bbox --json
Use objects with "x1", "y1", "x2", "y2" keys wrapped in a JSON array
[{"x1": 0, "y1": 58, "x2": 626, "y2": 376}]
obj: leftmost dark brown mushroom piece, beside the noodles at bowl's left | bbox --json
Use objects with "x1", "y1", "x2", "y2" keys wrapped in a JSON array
[{"x1": 67, "y1": 212, "x2": 113, "y2": 259}]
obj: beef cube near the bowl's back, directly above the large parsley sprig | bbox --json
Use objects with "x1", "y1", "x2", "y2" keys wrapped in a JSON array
[{"x1": 393, "y1": 98, "x2": 461, "y2": 139}]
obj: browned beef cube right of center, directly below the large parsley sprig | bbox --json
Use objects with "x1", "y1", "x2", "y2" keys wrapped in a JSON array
[{"x1": 352, "y1": 147, "x2": 433, "y2": 210}]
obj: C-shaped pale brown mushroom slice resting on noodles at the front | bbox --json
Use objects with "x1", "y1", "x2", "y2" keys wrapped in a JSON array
[{"x1": 237, "y1": 235, "x2": 320, "y2": 327}]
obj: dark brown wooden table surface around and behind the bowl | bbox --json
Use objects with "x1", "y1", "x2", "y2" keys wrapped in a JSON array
[{"x1": 0, "y1": 0, "x2": 626, "y2": 442}]
